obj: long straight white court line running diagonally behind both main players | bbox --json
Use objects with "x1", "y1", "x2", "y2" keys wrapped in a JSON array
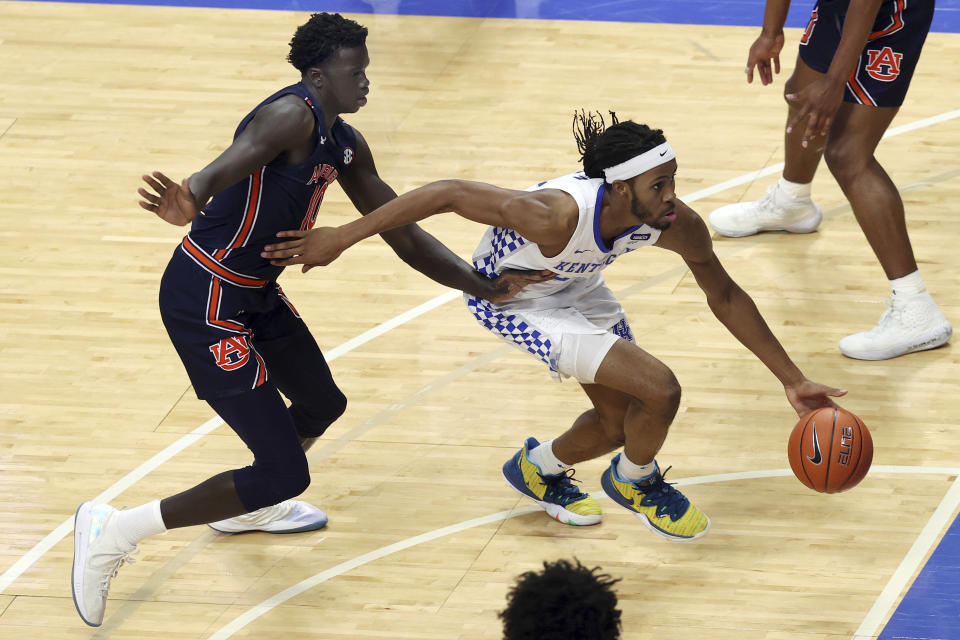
[{"x1": 0, "y1": 109, "x2": 960, "y2": 593}]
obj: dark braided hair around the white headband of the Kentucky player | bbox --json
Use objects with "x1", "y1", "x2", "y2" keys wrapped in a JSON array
[{"x1": 573, "y1": 109, "x2": 667, "y2": 178}]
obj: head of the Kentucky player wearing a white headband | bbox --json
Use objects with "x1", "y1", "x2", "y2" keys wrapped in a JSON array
[{"x1": 573, "y1": 110, "x2": 677, "y2": 231}]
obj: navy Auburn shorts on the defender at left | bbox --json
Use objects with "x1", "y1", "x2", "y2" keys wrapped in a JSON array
[{"x1": 160, "y1": 240, "x2": 316, "y2": 399}]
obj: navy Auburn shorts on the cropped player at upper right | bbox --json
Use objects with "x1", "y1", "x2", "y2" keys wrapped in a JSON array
[{"x1": 800, "y1": 0, "x2": 934, "y2": 107}]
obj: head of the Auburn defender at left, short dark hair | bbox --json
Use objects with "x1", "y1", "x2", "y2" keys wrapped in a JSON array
[{"x1": 287, "y1": 13, "x2": 370, "y2": 114}]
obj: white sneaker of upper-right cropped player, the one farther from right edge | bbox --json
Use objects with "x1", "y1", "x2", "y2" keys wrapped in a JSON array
[{"x1": 710, "y1": 184, "x2": 823, "y2": 238}]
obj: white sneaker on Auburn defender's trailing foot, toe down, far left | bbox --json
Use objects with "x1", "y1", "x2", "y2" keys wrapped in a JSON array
[{"x1": 72, "y1": 502, "x2": 137, "y2": 627}]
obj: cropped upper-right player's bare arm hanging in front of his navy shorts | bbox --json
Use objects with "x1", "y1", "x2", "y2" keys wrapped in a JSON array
[{"x1": 785, "y1": 0, "x2": 883, "y2": 147}]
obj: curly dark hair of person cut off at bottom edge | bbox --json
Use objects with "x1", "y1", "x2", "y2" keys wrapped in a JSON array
[{"x1": 499, "y1": 559, "x2": 620, "y2": 640}]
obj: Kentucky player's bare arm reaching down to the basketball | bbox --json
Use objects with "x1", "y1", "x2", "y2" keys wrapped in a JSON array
[{"x1": 657, "y1": 200, "x2": 846, "y2": 415}]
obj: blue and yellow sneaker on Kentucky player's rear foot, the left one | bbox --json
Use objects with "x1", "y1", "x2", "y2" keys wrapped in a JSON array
[{"x1": 503, "y1": 438, "x2": 603, "y2": 525}]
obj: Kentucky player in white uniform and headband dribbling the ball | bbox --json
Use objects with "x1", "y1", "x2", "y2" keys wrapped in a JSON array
[{"x1": 263, "y1": 112, "x2": 846, "y2": 540}]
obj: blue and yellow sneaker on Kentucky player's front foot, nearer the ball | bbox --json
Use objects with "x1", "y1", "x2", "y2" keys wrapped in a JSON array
[{"x1": 600, "y1": 453, "x2": 710, "y2": 540}]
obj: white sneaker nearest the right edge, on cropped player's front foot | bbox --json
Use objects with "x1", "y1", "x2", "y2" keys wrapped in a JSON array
[{"x1": 840, "y1": 292, "x2": 953, "y2": 360}]
